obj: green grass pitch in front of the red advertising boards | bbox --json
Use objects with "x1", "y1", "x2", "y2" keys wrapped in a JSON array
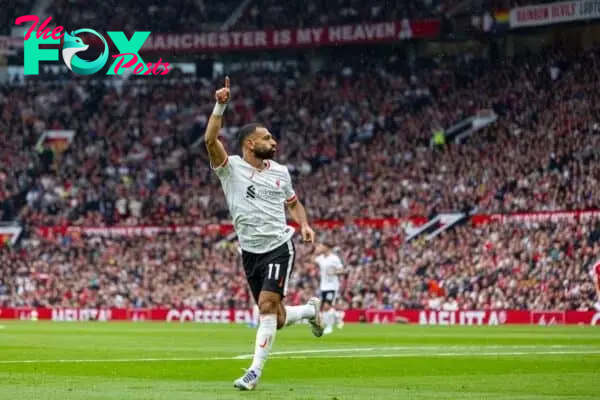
[{"x1": 0, "y1": 321, "x2": 600, "y2": 400}]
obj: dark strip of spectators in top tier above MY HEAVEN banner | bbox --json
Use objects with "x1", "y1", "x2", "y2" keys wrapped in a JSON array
[{"x1": 39, "y1": 0, "x2": 450, "y2": 33}]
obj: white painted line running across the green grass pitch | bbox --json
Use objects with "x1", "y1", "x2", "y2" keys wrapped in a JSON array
[{"x1": 0, "y1": 346, "x2": 600, "y2": 364}]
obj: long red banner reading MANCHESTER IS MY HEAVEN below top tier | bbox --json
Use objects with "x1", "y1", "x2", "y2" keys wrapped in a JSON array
[{"x1": 75, "y1": 19, "x2": 441, "y2": 54}]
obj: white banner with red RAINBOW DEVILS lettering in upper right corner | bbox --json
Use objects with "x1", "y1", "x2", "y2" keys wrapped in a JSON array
[{"x1": 510, "y1": 0, "x2": 600, "y2": 29}]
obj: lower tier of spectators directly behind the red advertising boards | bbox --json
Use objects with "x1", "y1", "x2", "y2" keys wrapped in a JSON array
[{"x1": 0, "y1": 219, "x2": 600, "y2": 310}]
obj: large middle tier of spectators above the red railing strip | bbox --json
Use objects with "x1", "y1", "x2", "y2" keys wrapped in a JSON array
[{"x1": 0, "y1": 45, "x2": 600, "y2": 225}]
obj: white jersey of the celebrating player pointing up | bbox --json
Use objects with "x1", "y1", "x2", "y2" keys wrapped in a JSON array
[{"x1": 213, "y1": 156, "x2": 296, "y2": 254}]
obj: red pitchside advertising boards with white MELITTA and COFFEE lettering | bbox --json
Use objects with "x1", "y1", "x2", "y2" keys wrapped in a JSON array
[{"x1": 0, "y1": 308, "x2": 600, "y2": 326}]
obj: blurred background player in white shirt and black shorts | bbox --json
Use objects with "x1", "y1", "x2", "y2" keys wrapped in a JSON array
[{"x1": 314, "y1": 242, "x2": 345, "y2": 334}]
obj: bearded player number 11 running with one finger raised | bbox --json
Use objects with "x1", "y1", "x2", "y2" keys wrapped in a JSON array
[{"x1": 205, "y1": 78, "x2": 323, "y2": 390}]
